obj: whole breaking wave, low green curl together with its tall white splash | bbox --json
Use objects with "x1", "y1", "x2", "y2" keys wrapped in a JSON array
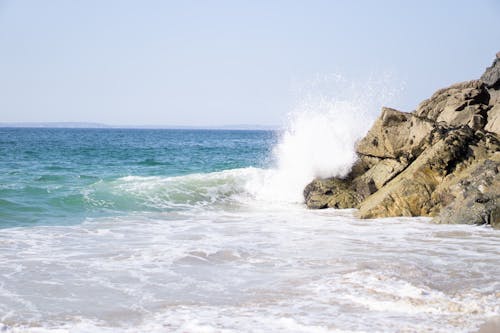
[{"x1": 80, "y1": 75, "x2": 394, "y2": 210}]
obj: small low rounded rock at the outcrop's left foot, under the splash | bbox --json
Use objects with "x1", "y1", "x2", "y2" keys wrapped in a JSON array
[{"x1": 304, "y1": 178, "x2": 360, "y2": 209}]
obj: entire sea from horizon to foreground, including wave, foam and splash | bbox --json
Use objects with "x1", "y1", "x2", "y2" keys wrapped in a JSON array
[{"x1": 0, "y1": 126, "x2": 500, "y2": 333}]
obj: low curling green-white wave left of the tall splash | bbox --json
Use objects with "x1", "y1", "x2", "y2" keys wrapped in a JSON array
[{"x1": 84, "y1": 168, "x2": 265, "y2": 211}]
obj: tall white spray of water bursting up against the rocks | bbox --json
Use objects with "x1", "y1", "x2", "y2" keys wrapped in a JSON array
[{"x1": 249, "y1": 75, "x2": 402, "y2": 202}]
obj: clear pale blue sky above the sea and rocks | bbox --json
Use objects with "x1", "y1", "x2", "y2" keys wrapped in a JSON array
[{"x1": 0, "y1": 0, "x2": 500, "y2": 126}]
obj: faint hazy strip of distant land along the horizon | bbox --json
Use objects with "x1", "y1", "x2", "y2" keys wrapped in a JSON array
[{"x1": 0, "y1": 122, "x2": 279, "y2": 131}]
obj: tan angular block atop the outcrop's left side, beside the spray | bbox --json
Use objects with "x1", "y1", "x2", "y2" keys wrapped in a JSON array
[{"x1": 356, "y1": 108, "x2": 433, "y2": 159}]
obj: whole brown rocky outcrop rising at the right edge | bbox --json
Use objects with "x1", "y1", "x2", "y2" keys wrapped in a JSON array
[{"x1": 304, "y1": 54, "x2": 500, "y2": 228}]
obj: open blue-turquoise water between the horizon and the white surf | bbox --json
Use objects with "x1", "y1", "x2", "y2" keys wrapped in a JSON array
[{"x1": 0, "y1": 128, "x2": 276, "y2": 228}]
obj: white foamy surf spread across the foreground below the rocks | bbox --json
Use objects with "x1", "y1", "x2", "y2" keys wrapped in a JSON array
[{"x1": 0, "y1": 209, "x2": 500, "y2": 332}]
